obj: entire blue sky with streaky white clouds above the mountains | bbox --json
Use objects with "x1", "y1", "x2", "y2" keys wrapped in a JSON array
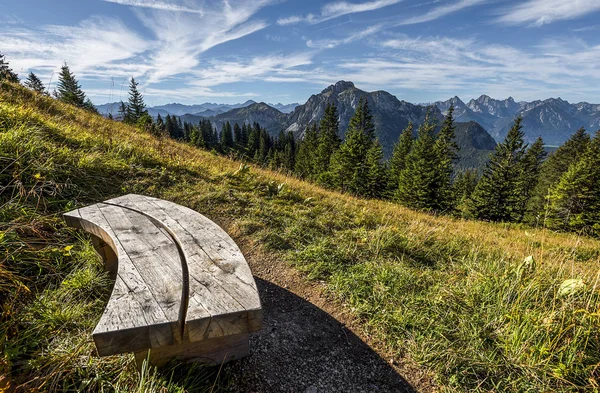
[{"x1": 0, "y1": 0, "x2": 600, "y2": 105}]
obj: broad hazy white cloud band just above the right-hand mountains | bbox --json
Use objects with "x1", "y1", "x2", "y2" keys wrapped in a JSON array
[{"x1": 330, "y1": 36, "x2": 600, "y2": 99}]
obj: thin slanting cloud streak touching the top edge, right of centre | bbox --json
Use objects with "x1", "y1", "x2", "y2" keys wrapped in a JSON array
[{"x1": 277, "y1": 0, "x2": 402, "y2": 26}]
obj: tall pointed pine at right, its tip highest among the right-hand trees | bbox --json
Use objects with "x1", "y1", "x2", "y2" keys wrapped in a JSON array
[{"x1": 471, "y1": 117, "x2": 525, "y2": 222}]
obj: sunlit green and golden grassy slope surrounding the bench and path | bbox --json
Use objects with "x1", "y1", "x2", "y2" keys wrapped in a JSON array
[{"x1": 0, "y1": 84, "x2": 600, "y2": 391}]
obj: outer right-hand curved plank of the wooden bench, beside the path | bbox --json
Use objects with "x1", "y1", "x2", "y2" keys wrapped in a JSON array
[{"x1": 107, "y1": 195, "x2": 262, "y2": 341}]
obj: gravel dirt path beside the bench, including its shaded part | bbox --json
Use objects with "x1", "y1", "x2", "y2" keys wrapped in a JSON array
[{"x1": 228, "y1": 238, "x2": 436, "y2": 393}]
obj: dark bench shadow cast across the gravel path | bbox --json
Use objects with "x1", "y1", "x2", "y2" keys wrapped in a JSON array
[{"x1": 228, "y1": 277, "x2": 416, "y2": 393}]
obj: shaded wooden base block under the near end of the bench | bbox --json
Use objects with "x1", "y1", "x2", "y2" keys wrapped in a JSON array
[{"x1": 135, "y1": 333, "x2": 250, "y2": 369}]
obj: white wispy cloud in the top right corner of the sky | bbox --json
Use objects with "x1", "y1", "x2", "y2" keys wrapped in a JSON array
[{"x1": 498, "y1": 0, "x2": 600, "y2": 26}]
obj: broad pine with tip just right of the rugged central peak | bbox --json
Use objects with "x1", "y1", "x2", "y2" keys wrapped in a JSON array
[{"x1": 331, "y1": 97, "x2": 375, "y2": 195}]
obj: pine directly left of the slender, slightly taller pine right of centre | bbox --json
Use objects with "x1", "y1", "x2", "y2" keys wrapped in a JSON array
[{"x1": 394, "y1": 115, "x2": 439, "y2": 210}]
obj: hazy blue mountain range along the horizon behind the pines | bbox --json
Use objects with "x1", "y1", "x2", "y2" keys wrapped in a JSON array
[{"x1": 97, "y1": 81, "x2": 600, "y2": 167}]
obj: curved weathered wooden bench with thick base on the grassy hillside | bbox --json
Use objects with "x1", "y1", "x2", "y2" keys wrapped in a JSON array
[{"x1": 64, "y1": 194, "x2": 262, "y2": 366}]
